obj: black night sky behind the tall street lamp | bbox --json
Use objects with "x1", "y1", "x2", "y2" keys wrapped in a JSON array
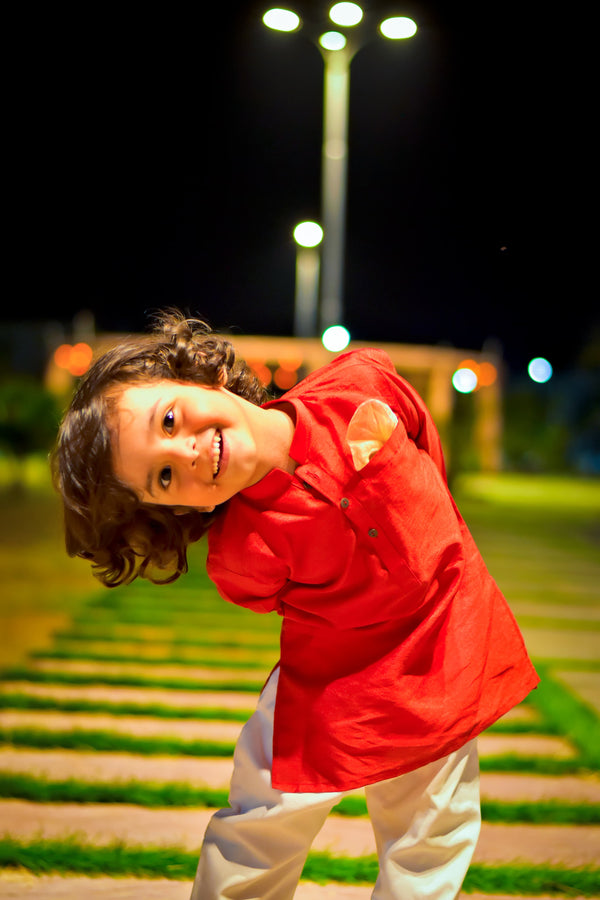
[{"x1": 2, "y1": 0, "x2": 598, "y2": 371}]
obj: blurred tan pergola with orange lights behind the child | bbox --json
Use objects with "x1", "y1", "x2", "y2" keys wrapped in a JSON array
[{"x1": 46, "y1": 333, "x2": 502, "y2": 472}]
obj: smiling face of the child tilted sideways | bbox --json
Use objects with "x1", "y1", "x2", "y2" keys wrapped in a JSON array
[{"x1": 110, "y1": 380, "x2": 264, "y2": 510}]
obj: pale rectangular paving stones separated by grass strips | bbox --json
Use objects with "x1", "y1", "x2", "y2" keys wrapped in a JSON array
[{"x1": 0, "y1": 552, "x2": 600, "y2": 900}]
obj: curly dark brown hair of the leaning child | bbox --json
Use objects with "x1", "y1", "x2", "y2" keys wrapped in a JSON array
[{"x1": 50, "y1": 310, "x2": 268, "y2": 587}]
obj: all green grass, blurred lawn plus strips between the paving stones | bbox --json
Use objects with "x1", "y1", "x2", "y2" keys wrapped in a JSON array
[{"x1": 0, "y1": 475, "x2": 600, "y2": 897}]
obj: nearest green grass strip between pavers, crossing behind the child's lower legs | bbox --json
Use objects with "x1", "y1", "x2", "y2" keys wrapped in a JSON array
[{"x1": 0, "y1": 838, "x2": 600, "y2": 897}]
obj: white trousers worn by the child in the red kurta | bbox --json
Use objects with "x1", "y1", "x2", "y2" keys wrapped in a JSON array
[{"x1": 190, "y1": 669, "x2": 481, "y2": 900}]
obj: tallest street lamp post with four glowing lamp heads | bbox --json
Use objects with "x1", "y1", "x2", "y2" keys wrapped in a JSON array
[{"x1": 263, "y1": 3, "x2": 417, "y2": 331}]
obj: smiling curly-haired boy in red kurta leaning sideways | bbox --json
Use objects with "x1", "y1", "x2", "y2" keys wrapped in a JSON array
[{"x1": 54, "y1": 313, "x2": 538, "y2": 900}]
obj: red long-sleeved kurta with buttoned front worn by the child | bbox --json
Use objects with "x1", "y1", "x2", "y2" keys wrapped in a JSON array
[{"x1": 208, "y1": 350, "x2": 538, "y2": 791}]
